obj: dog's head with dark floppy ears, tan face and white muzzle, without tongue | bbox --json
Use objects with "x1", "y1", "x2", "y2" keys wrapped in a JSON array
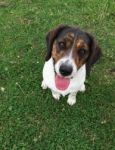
[{"x1": 46, "y1": 25, "x2": 101, "y2": 78}]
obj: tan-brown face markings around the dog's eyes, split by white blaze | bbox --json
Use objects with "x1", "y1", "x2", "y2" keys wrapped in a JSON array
[{"x1": 52, "y1": 33, "x2": 88, "y2": 68}]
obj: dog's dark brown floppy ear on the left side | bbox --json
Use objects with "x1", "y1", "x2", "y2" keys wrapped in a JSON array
[{"x1": 45, "y1": 25, "x2": 69, "y2": 61}]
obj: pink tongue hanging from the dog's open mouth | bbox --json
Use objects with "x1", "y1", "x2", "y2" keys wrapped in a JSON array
[{"x1": 55, "y1": 75, "x2": 70, "y2": 90}]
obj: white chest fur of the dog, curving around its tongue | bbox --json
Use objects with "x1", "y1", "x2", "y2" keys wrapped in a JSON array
[{"x1": 43, "y1": 58, "x2": 86, "y2": 96}]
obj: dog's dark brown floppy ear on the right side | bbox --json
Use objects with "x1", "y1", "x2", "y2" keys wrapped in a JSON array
[{"x1": 86, "y1": 33, "x2": 102, "y2": 75}]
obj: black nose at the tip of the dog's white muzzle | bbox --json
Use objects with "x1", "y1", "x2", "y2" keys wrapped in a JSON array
[{"x1": 59, "y1": 64, "x2": 73, "y2": 76}]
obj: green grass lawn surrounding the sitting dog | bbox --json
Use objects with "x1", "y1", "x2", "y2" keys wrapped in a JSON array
[{"x1": 0, "y1": 0, "x2": 115, "y2": 150}]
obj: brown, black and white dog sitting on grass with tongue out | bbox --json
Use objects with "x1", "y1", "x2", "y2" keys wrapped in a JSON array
[{"x1": 41, "y1": 25, "x2": 101, "y2": 106}]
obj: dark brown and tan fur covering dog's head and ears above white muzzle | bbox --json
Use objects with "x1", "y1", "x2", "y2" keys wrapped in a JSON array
[{"x1": 45, "y1": 25, "x2": 101, "y2": 75}]
